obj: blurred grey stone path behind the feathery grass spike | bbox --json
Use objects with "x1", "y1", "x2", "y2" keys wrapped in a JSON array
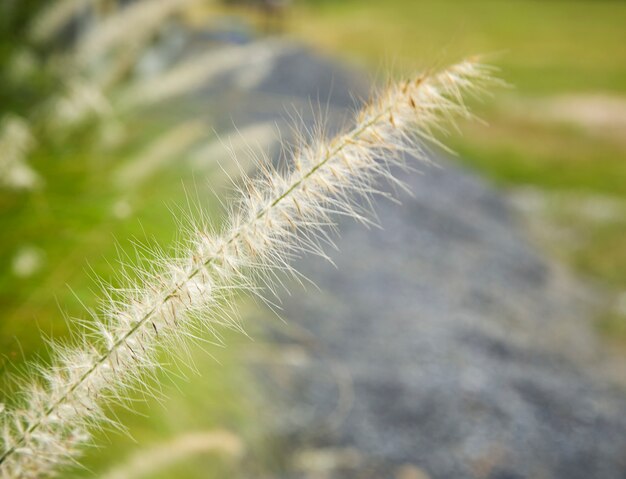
[{"x1": 152, "y1": 31, "x2": 626, "y2": 479}]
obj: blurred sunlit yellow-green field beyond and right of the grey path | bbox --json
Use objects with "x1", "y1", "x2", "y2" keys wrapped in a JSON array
[{"x1": 291, "y1": 0, "x2": 626, "y2": 339}]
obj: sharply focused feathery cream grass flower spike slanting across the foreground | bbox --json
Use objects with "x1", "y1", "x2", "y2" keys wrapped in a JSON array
[{"x1": 0, "y1": 61, "x2": 489, "y2": 479}]
